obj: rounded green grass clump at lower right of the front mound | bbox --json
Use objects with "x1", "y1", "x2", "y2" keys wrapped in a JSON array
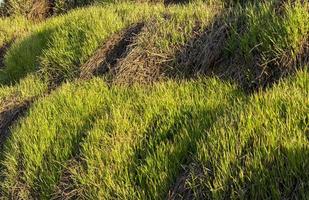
[{"x1": 186, "y1": 68, "x2": 309, "y2": 199}]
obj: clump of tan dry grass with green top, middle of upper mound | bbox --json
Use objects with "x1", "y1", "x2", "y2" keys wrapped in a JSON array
[{"x1": 113, "y1": 3, "x2": 220, "y2": 84}]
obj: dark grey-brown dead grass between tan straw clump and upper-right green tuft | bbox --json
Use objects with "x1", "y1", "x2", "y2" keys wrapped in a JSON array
[{"x1": 175, "y1": 18, "x2": 229, "y2": 77}]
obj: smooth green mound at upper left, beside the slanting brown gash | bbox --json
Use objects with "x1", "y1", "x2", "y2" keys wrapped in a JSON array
[{"x1": 2, "y1": 4, "x2": 166, "y2": 82}]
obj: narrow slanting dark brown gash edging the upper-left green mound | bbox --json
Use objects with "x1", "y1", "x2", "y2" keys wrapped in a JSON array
[{"x1": 80, "y1": 23, "x2": 144, "y2": 79}]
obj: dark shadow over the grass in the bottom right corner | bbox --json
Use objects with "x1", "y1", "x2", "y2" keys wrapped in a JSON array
[{"x1": 170, "y1": 145, "x2": 309, "y2": 199}]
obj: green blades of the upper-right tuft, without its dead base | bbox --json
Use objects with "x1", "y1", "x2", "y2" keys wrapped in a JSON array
[{"x1": 227, "y1": 1, "x2": 309, "y2": 67}]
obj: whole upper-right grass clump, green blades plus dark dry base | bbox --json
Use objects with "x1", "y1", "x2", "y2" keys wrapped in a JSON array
[{"x1": 226, "y1": 1, "x2": 309, "y2": 86}]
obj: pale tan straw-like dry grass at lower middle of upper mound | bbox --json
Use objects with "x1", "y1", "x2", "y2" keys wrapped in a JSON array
[{"x1": 112, "y1": 20, "x2": 180, "y2": 85}]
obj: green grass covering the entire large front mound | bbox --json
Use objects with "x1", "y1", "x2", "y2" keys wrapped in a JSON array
[{"x1": 1, "y1": 71, "x2": 309, "y2": 199}]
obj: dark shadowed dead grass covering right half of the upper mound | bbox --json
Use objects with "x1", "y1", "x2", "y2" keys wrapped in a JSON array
[{"x1": 165, "y1": 2, "x2": 309, "y2": 94}]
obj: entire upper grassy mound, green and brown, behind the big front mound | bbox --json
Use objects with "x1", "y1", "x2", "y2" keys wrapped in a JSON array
[{"x1": 2, "y1": 1, "x2": 309, "y2": 88}]
